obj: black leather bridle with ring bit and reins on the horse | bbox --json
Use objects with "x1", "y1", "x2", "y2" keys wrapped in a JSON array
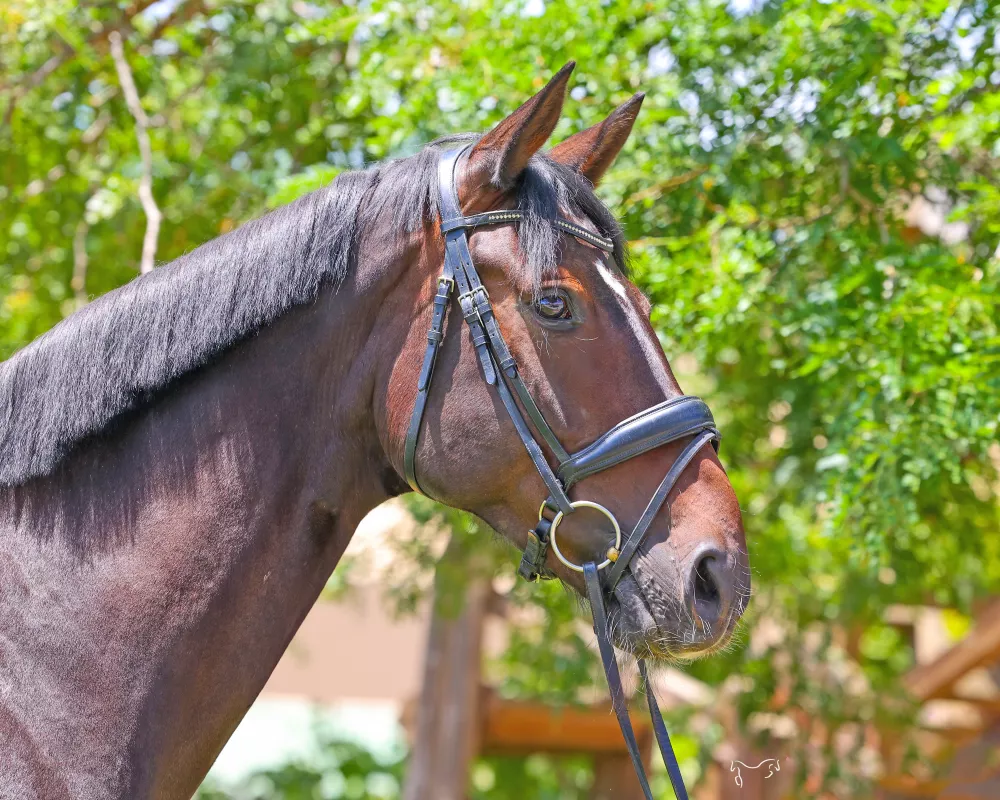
[{"x1": 403, "y1": 145, "x2": 720, "y2": 800}]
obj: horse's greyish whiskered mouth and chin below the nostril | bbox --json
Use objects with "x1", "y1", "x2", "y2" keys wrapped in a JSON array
[{"x1": 607, "y1": 574, "x2": 731, "y2": 663}]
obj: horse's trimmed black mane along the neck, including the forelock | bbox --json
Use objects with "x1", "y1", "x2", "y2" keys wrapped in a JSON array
[{"x1": 0, "y1": 138, "x2": 625, "y2": 487}]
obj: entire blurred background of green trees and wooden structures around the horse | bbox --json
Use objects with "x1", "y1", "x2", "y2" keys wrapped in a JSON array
[{"x1": 0, "y1": 0, "x2": 1000, "y2": 800}]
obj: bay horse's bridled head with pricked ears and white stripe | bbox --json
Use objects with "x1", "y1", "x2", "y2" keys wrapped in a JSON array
[{"x1": 381, "y1": 65, "x2": 749, "y2": 657}]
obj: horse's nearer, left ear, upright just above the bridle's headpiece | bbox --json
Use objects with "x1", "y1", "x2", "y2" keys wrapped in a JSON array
[{"x1": 463, "y1": 61, "x2": 576, "y2": 198}]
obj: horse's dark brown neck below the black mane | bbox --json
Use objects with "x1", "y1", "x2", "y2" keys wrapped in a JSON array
[{"x1": 0, "y1": 260, "x2": 408, "y2": 798}]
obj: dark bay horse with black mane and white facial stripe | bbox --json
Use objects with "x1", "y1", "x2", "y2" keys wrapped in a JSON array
[{"x1": 0, "y1": 64, "x2": 749, "y2": 800}]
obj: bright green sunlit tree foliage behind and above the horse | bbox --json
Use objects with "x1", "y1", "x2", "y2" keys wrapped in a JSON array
[{"x1": 0, "y1": 0, "x2": 1000, "y2": 796}]
